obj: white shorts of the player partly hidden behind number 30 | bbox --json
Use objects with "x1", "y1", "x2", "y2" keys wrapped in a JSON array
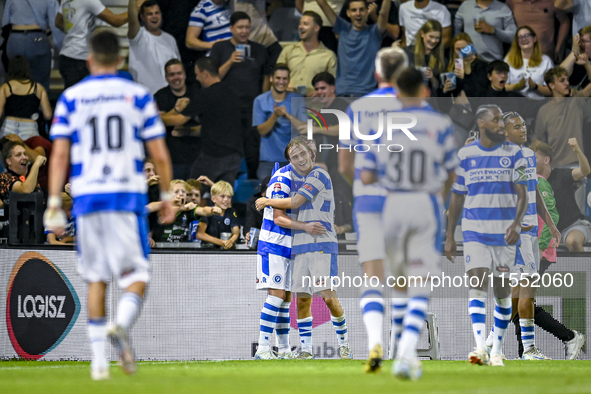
[{"x1": 355, "y1": 212, "x2": 386, "y2": 264}]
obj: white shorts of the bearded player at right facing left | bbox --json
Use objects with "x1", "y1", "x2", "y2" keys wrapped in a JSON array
[{"x1": 464, "y1": 242, "x2": 516, "y2": 277}]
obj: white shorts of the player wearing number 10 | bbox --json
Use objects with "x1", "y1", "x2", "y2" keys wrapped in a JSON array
[{"x1": 76, "y1": 212, "x2": 150, "y2": 289}]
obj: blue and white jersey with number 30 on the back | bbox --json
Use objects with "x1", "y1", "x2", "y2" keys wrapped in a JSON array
[{"x1": 364, "y1": 107, "x2": 458, "y2": 194}]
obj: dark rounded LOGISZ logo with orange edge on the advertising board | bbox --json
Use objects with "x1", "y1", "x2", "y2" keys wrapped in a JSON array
[{"x1": 6, "y1": 252, "x2": 80, "y2": 360}]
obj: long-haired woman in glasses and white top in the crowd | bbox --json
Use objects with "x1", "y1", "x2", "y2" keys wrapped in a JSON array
[{"x1": 505, "y1": 26, "x2": 554, "y2": 98}]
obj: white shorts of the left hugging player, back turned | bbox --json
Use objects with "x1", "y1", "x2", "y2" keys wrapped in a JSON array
[{"x1": 257, "y1": 253, "x2": 293, "y2": 291}]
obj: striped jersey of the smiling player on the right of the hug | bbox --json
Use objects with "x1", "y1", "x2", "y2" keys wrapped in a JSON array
[{"x1": 292, "y1": 167, "x2": 339, "y2": 255}]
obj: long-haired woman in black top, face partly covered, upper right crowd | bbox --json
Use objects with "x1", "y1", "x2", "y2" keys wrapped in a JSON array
[{"x1": 442, "y1": 33, "x2": 488, "y2": 97}]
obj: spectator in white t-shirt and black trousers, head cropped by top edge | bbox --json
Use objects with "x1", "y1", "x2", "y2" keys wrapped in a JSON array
[{"x1": 55, "y1": 0, "x2": 127, "y2": 89}]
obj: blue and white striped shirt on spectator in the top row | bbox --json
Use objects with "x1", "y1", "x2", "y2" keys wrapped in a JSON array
[{"x1": 189, "y1": 0, "x2": 232, "y2": 42}]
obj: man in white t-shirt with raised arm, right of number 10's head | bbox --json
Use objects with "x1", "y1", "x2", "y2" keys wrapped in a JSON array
[{"x1": 127, "y1": 0, "x2": 181, "y2": 94}]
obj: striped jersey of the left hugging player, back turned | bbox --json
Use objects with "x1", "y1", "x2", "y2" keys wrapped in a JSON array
[{"x1": 257, "y1": 164, "x2": 305, "y2": 259}]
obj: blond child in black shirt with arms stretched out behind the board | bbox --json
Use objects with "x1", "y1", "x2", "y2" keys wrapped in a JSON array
[{"x1": 148, "y1": 179, "x2": 222, "y2": 246}]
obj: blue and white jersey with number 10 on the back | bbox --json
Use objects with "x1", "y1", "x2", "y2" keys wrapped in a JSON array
[{"x1": 50, "y1": 75, "x2": 166, "y2": 216}]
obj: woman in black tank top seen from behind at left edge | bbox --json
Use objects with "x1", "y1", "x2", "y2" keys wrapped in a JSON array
[{"x1": 0, "y1": 56, "x2": 53, "y2": 140}]
